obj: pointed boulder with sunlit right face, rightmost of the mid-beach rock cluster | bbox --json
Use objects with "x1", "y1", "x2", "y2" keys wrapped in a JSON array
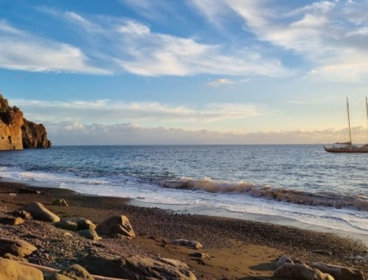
[{"x1": 96, "y1": 215, "x2": 135, "y2": 238}]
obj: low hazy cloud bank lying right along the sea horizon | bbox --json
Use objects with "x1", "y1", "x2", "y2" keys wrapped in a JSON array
[{"x1": 46, "y1": 122, "x2": 368, "y2": 145}]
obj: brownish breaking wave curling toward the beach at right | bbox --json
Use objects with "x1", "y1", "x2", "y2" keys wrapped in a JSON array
[{"x1": 160, "y1": 177, "x2": 368, "y2": 211}]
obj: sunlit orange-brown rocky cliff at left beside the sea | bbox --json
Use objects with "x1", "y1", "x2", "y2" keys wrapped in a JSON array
[{"x1": 0, "y1": 94, "x2": 51, "y2": 150}]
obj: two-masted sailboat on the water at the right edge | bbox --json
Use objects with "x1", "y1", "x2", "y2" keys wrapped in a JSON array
[{"x1": 323, "y1": 97, "x2": 368, "y2": 153}]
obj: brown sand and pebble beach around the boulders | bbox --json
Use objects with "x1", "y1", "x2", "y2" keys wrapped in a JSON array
[{"x1": 0, "y1": 182, "x2": 368, "y2": 279}]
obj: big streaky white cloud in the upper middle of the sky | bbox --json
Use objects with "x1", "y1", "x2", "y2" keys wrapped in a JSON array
[{"x1": 51, "y1": 10, "x2": 290, "y2": 77}]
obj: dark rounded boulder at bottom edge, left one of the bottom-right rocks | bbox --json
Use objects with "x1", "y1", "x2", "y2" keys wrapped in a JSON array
[{"x1": 274, "y1": 263, "x2": 335, "y2": 280}]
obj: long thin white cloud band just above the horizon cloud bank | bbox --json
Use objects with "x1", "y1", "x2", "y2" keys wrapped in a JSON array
[{"x1": 11, "y1": 99, "x2": 264, "y2": 124}]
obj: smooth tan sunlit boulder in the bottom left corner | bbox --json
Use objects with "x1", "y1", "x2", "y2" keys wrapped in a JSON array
[{"x1": 0, "y1": 258, "x2": 43, "y2": 280}]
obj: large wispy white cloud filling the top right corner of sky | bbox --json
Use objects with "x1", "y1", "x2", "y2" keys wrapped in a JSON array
[{"x1": 197, "y1": 0, "x2": 368, "y2": 82}]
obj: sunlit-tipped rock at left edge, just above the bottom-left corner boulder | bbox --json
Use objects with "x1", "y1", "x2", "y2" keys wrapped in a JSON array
[{"x1": 0, "y1": 238, "x2": 37, "y2": 257}]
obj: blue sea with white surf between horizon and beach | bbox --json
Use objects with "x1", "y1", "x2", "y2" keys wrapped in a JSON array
[{"x1": 0, "y1": 145, "x2": 368, "y2": 242}]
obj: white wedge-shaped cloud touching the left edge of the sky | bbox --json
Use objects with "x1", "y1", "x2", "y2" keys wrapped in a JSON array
[{"x1": 0, "y1": 21, "x2": 109, "y2": 74}]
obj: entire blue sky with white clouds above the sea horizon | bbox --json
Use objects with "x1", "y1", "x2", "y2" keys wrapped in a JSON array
[{"x1": 0, "y1": 0, "x2": 368, "y2": 145}]
